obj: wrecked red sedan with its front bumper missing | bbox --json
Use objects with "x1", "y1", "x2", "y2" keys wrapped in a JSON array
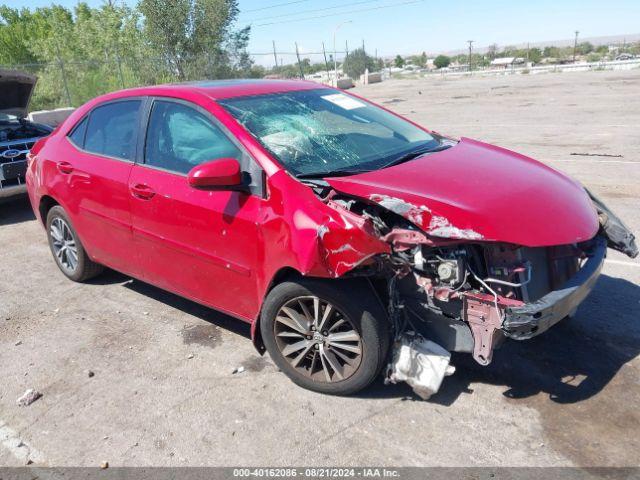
[{"x1": 26, "y1": 80, "x2": 638, "y2": 396}]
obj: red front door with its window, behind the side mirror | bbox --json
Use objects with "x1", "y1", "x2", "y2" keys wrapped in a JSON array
[{"x1": 129, "y1": 98, "x2": 262, "y2": 318}]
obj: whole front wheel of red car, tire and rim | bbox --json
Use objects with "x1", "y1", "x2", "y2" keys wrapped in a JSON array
[{"x1": 260, "y1": 279, "x2": 390, "y2": 395}]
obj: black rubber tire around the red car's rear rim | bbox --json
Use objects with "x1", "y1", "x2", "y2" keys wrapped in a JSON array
[{"x1": 47, "y1": 205, "x2": 104, "y2": 282}]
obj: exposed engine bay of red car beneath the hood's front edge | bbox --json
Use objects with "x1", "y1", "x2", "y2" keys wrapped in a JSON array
[{"x1": 324, "y1": 189, "x2": 586, "y2": 365}]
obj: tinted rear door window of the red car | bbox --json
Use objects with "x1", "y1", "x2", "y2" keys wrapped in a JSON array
[{"x1": 84, "y1": 100, "x2": 142, "y2": 161}]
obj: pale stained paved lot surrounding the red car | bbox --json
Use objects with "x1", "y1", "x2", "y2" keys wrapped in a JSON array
[{"x1": 0, "y1": 70, "x2": 640, "y2": 466}]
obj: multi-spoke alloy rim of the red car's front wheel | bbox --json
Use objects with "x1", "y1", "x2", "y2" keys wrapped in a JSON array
[{"x1": 273, "y1": 296, "x2": 362, "y2": 383}]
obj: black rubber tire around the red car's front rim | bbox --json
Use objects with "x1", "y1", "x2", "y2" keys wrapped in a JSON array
[{"x1": 260, "y1": 278, "x2": 391, "y2": 395}]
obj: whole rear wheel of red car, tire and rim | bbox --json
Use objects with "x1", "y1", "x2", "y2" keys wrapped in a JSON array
[{"x1": 47, "y1": 205, "x2": 103, "y2": 282}]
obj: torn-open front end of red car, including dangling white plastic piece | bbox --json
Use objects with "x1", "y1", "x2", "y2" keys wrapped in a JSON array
[{"x1": 302, "y1": 181, "x2": 637, "y2": 396}]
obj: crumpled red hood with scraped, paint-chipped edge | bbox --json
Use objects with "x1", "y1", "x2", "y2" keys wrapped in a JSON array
[{"x1": 326, "y1": 138, "x2": 599, "y2": 247}]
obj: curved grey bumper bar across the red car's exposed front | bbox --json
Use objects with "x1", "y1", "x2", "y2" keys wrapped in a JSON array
[{"x1": 502, "y1": 237, "x2": 607, "y2": 340}]
